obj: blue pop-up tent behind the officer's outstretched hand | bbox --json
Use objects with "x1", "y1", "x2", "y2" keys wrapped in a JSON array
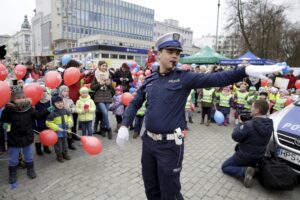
[{"x1": 219, "y1": 51, "x2": 276, "y2": 65}]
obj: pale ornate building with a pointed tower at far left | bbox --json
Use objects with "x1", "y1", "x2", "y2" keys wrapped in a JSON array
[{"x1": 6, "y1": 15, "x2": 32, "y2": 63}]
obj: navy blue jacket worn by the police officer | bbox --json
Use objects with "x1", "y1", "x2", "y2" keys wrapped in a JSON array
[{"x1": 122, "y1": 68, "x2": 247, "y2": 134}]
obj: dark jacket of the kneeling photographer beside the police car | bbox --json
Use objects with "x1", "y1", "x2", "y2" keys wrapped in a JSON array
[{"x1": 232, "y1": 117, "x2": 273, "y2": 165}]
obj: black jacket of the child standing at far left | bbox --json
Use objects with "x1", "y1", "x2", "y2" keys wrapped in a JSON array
[{"x1": 1, "y1": 103, "x2": 49, "y2": 147}]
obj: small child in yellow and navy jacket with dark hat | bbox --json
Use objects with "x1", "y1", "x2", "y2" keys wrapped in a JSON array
[{"x1": 46, "y1": 95, "x2": 73, "y2": 163}]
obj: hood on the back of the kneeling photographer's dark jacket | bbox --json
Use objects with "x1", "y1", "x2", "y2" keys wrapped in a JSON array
[{"x1": 252, "y1": 117, "x2": 274, "y2": 137}]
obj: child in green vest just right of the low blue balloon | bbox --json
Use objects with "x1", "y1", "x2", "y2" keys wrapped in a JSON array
[{"x1": 217, "y1": 87, "x2": 233, "y2": 126}]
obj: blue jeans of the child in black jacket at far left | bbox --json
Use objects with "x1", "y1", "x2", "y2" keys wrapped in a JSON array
[{"x1": 8, "y1": 144, "x2": 33, "y2": 167}]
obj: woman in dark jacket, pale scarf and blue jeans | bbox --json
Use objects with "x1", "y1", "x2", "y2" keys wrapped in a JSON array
[{"x1": 91, "y1": 61, "x2": 114, "y2": 139}]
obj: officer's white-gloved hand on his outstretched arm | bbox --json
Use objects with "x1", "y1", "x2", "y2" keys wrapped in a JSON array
[{"x1": 245, "y1": 63, "x2": 288, "y2": 79}]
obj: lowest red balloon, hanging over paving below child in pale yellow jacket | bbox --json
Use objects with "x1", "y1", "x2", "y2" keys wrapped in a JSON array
[{"x1": 80, "y1": 136, "x2": 102, "y2": 155}]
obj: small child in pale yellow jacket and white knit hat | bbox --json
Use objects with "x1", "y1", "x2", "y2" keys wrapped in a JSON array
[{"x1": 76, "y1": 87, "x2": 96, "y2": 136}]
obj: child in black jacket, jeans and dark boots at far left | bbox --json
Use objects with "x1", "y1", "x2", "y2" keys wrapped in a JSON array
[{"x1": 1, "y1": 86, "x2": 50, "y2": 184}]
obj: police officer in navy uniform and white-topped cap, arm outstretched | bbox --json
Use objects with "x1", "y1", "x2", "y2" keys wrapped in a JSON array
[{"x1": 116, "y1": 33, "x2": 283, "y2": 200}]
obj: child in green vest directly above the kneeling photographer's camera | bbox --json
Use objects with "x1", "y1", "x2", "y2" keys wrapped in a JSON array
[{"x1": 234, "y1": 83, "x2": 249, "y2": 124}]
